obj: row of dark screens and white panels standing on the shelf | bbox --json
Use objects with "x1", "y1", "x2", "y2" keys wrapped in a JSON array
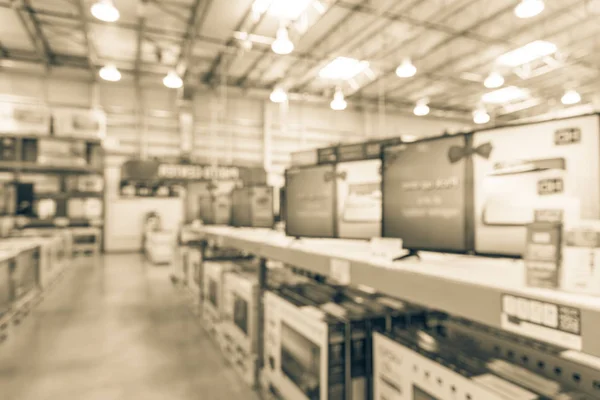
[{"x1": 282, "y1": 115, "x2": 600, "y2": 257}]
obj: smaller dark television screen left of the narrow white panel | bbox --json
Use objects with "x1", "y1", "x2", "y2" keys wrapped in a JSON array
[{"x1": 285, "y1": 165, "x2": 335, "y2": 237}]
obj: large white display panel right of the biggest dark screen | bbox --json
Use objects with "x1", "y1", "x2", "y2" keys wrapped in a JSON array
[{"x1": 473, "y1": 115, "x2": 600, "y2": 256}]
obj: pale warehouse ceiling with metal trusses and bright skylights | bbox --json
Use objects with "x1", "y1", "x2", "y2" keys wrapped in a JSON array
[{"x1": 0, "y1": 0, "x2": 600, "y2": 123}]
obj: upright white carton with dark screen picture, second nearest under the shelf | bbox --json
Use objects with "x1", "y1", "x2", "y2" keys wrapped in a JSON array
[{"x1": 263, "y1": 284, "x2": 424, "y2": 400}]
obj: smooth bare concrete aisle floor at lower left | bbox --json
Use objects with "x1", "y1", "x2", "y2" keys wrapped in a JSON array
[{"x1": 0, "y1": 255, "x2": 258, "y2": 400}]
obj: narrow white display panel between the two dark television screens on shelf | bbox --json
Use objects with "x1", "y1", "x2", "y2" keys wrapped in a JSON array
[{"x1": 336, "y1": 160, "x2": 381, "y2": 239}]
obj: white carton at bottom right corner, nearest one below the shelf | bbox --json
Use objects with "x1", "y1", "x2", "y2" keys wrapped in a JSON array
[{"x1": 373, "y1": 329, "x2": 586, "y2": 400}]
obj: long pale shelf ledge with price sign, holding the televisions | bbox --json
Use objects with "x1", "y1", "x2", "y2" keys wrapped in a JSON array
[{"x1": 197, "y1": 226, "x2": 600, "y2": 357}]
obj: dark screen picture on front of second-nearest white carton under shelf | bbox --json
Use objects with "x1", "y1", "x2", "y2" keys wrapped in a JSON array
[{"x1": 281, "y1": 322, "x2": 321, "y2": 400}]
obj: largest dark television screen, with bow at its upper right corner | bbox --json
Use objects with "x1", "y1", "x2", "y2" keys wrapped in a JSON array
[{"x1": 382, "y1": 135, "x2": 473, "y2": 252}]
